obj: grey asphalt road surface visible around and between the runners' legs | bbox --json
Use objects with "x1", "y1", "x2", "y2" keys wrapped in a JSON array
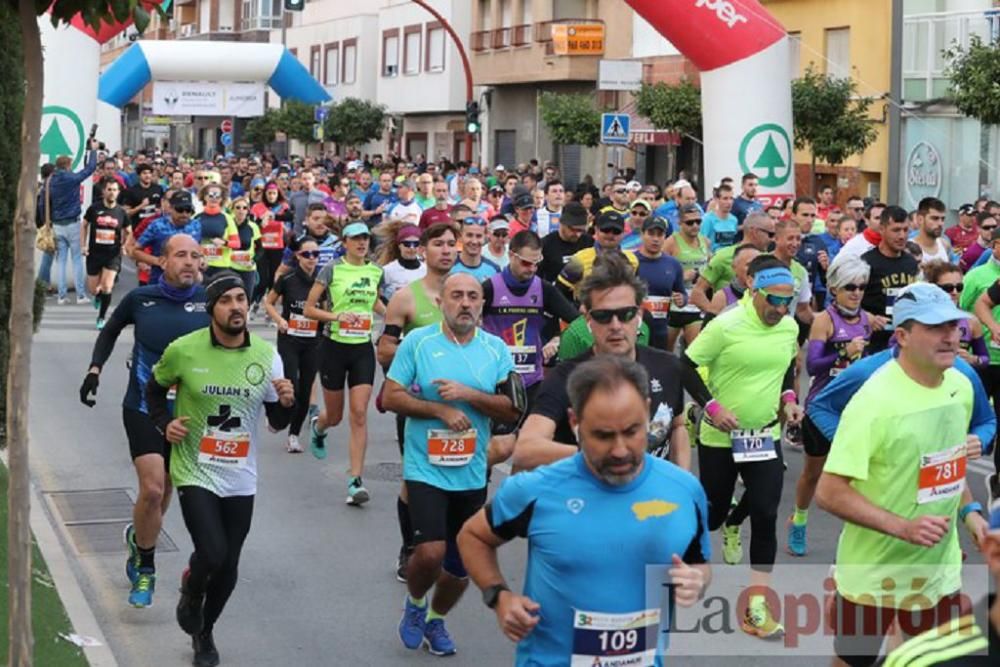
[{"x1": 31, "y1": 275, "x2": 988, "y2": 667}]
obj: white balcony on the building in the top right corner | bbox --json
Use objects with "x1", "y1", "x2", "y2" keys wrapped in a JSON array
[{"x1": 903, "y1": 9, "x2": 1000, "y2": 102}]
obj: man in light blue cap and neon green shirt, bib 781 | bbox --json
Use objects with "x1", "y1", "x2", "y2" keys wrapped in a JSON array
[{"x1": 816, "y1": 283, "x2": 983, "y2": 667}]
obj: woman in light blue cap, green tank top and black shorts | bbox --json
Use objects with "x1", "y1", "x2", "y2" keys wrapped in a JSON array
[{"x1": 304, "y1": 222, "x2": 385, "y2": 505}]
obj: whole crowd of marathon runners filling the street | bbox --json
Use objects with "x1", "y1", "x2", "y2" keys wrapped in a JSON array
[{"x1": 58, "y1": 147, "x2": 1000, "y2": 666}]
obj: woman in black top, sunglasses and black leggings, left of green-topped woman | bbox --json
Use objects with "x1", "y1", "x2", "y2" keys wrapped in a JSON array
[{"x1": 264, "y1": 237, "x2": 320, "y2": 454}]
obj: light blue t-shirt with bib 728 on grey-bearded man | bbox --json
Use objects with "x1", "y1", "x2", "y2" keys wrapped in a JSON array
[{"x1": 386, "y1": 323, "x2": 514, "y2": 491}]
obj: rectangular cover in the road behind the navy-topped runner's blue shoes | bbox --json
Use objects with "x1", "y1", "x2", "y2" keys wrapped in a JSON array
[{"x1": 44, "y1": 489, "x2": 177, "y2": 555}]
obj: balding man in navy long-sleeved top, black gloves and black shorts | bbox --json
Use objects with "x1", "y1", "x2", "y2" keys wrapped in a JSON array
[{"x1": 80, "y1": 234, "x2": 208, "y2": 608}]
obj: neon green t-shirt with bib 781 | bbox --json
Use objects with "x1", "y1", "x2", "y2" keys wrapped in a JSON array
[{"x1": 823, "y1": 361, "x2": 973, "y2": 607}]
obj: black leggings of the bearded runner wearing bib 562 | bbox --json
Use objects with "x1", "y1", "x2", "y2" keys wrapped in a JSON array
[{"x1": 177, "y1": 486, "x2": 254, "y2": 632}]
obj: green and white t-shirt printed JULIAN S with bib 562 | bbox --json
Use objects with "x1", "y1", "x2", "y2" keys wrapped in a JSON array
[{"x1": 153, "y1": 327, "x2": 284, "y2": 497}]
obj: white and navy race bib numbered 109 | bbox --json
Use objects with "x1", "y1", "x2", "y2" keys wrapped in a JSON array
[{"x1": 570, "y1": 609, "x2": 660, "y2": 667}]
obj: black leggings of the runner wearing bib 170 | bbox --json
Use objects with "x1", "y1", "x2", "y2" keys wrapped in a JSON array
[{"x1": 698, "y1": 441, "x2": 785, "y2": 572}]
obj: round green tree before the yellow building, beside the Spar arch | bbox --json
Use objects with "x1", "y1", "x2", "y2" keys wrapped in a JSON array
[{"x1": 792, "y1": 64, "x2": 878, "y2": 187}]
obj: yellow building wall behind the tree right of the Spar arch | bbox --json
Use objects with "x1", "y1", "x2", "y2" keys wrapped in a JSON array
[{"x1": 763, "y1": 0, "x2": 892, "y2": 199}]
